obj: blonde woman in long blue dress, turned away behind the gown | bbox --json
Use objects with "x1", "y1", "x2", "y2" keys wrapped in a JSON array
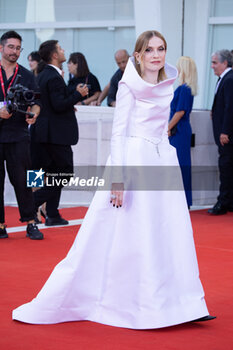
[{"x1": 168, "y1": 56, "x2": 197, "y2": 208}]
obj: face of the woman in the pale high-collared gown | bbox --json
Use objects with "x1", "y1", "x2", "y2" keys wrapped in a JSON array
[{"x1": 136, "y1": 36, "x2": 166, "y2": 74}]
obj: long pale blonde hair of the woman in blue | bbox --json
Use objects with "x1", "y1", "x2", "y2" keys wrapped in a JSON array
[{"x1": 176, "y1": 56, "x2": 197, "y2": 96}]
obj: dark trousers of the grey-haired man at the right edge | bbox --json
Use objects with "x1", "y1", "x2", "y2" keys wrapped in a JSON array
[{"x1": 218, "y1": 144, "x2": 233, "y2": 206}]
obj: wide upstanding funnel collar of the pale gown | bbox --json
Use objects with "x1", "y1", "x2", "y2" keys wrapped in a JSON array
[{"x1": 120, "y1": 57, "x2": 177, "y2": 99}]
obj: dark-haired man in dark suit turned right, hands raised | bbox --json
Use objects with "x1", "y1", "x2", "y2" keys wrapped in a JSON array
[{"x1": 33, "y1": 40, "x2": 88, "y2": 226}]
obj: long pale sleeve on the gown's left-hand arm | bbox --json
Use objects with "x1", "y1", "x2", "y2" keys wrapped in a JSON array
[{"x1": 111, "y1": 83, "x2": 135, "y2": 182}]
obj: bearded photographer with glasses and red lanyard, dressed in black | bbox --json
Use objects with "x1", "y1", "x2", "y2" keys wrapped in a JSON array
[{"x1": 0, "y1": 31, "x2": 43, "y2": 240}]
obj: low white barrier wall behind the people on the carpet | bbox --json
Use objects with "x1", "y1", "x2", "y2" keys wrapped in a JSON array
[{"x1": 5, "y1": 106, "x2": 218, "y2": 206}]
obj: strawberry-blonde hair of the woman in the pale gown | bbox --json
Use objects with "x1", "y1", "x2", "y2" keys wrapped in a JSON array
[{"x1": 134, "y1": 30, "x2": 167, "y2": 82}]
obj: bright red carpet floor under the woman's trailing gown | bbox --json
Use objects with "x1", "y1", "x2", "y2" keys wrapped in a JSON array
[{"x1": 0, "y1": 208, "x2": 233, "y2": 350}]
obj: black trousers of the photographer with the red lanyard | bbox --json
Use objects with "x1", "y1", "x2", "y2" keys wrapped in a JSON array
[{"x1": 0, "y1": 141, "x2": 35, "y2": 223}]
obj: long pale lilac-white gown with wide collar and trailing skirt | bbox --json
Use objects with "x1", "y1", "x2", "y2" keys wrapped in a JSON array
[{"x1": 13, "y1": 58, "x2": 209, "y2": 329}]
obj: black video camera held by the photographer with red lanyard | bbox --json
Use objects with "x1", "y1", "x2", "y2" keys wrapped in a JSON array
[{"x1": 6, "y1": 74, "x2": 40, "y2": 118}]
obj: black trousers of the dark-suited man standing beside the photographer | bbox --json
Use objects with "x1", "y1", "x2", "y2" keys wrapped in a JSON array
[{"x1": 33, "y1": 143, "x2": 73, "y2": 218}]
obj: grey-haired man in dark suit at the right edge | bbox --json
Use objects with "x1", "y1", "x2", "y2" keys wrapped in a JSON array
[{"x1": 208, "y1": 50, "x2": 233, "y2": 215}]
